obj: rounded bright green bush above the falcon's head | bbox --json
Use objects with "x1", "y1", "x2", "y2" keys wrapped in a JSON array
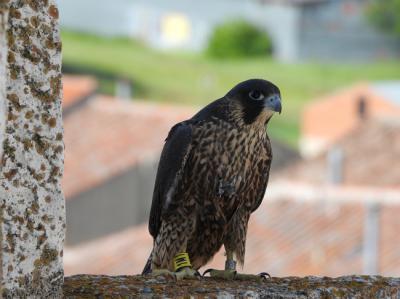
[{"x1": 206, "y1": 20, "x2": 271, "y2": 58}]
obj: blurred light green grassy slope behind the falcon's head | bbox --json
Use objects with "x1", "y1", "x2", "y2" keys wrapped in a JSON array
[{"x1": 62, "y1": 31, "x2": 400, "y2": 146}]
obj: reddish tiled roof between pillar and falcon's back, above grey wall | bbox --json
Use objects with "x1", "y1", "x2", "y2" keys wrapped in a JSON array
[{"x1": 63, "y1": 96, "x2": 193, "y2": 199}]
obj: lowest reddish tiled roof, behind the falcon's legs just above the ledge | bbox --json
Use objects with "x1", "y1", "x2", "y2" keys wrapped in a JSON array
[{"x1": 64, "y1": 183, "x2": 400, "y2": 276}]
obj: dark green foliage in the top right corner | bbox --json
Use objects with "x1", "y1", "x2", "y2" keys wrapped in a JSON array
[{"x1": 367, "y1": 0, "x2": 400, "y2": 37}]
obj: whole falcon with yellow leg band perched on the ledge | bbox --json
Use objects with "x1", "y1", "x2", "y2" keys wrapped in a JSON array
[{"x1": 142, "y1": 79, "x2": 282, "y2": 279}]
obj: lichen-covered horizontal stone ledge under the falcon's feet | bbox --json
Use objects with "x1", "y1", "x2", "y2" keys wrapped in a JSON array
[{"x1": 64, "y1": 275, "x2": 400, "y2": 299}]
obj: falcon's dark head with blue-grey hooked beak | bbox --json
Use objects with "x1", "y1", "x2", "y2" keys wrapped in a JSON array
[{"x1": 226, "y1": 79, "x2": 282, "y2": 124}]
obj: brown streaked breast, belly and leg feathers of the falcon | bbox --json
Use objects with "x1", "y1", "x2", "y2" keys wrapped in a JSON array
[{"x1": 151, "y1": 113, "x2": 272, "y2": 271}]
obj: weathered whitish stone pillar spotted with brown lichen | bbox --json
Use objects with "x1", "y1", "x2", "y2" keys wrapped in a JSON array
[{"x1": 0, "y1": 0, "x2": 65, "y2": 298}]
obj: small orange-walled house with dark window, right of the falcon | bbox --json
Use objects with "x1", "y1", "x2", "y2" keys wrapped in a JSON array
[{"x1": 300, "y1": 81, "x2": 400, "y2": 157}]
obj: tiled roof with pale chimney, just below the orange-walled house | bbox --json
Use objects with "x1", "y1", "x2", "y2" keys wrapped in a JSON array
[{"x1": 286, "y1": 119, "x2": 400, "y2": 188}]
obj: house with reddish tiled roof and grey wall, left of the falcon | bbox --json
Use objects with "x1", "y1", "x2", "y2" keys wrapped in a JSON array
[{"x1": 62, "y1": 77, "x2": 299, "y2": 245}]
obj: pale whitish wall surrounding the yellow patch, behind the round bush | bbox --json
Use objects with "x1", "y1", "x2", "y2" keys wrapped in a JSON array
[{"x1": 57, "y1": 0, "x2": 300, "y2": 61}]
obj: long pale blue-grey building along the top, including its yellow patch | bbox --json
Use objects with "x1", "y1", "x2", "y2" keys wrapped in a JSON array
[{"x1": 57, "y1": 0, "x2": 400, "y2": 61}]
